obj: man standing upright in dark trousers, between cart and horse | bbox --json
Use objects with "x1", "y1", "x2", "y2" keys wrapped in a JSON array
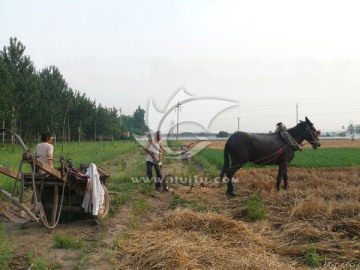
[{"x1": 144, "y1": 131, "x2": 163, "y2": 191}]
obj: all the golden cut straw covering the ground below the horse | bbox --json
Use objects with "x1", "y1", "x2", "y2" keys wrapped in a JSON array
[{"x1": 116, "y1": 168, "x2": 360, "y2": 269}]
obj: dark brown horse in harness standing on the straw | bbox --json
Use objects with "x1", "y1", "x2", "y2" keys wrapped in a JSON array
[{"x1": 220, "y1": 117, "x2": 320, "y2": 196}]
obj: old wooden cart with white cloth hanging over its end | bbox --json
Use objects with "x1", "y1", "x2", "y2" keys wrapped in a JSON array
[{"x1": 0, "y1": 128, "x2": 110, "y2": 228}]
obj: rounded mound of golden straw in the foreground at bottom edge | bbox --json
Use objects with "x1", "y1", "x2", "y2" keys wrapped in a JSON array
[{"x1": 117, "y1": 209, "x2": 295, "y2": 270}]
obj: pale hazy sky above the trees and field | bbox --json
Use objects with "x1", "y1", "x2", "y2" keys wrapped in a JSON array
[{"x1": 0, "y1": 0, "x2": 360, "y2": 133}]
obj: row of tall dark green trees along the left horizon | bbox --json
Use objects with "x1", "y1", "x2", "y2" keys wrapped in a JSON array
[{"x1": 0, "y1": 38, "x2": 148, "y2": 141}]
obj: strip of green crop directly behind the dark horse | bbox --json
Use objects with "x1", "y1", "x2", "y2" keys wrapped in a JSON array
[{"x1": 193, "y1": 148, "x2": 360, "y2": 170}]
